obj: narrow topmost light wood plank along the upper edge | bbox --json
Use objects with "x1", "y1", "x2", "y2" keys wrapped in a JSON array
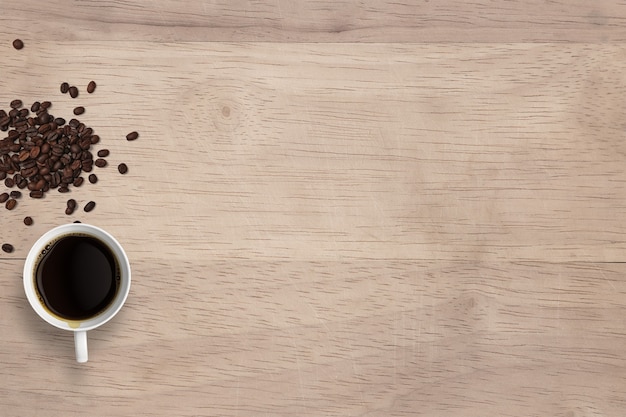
[{"x1": 1, "y1": 0, "x2": 626, "y2": 43}]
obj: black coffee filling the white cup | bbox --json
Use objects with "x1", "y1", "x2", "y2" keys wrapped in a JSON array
[{"x1": 35, "y1": 235, "x2": 119, "y2": 320}]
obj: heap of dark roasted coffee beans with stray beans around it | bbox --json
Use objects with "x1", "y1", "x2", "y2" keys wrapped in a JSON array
[{"x1": 0, "y1": 39, "x2": 139, "y2": 253}]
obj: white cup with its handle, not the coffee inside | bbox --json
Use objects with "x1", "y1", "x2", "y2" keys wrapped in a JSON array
[{"x1": 24, "y1": 223, "x2": 130, "y2": 363}]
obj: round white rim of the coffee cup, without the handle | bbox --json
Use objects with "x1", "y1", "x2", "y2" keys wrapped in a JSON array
[{"x1": 22, "y1": 223, "x2": 131, "y2": 331}]
